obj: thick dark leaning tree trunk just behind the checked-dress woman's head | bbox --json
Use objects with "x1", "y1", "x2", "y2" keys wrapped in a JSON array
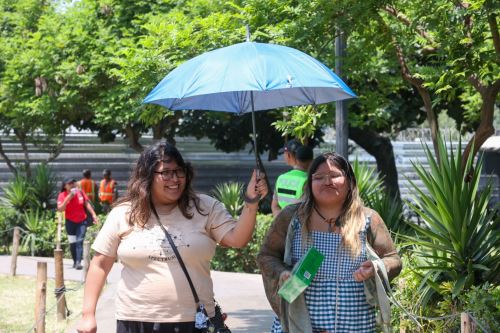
[{"x1": 349, "y1": 126, "x2": 401, "y2": 200}]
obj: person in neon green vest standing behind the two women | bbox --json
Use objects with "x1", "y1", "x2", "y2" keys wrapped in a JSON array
[{"x1": 271, "y1": 139, "x2": 314, "y2": 216}]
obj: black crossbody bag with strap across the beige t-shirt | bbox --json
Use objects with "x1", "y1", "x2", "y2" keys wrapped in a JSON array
[{"x1": 153, "y1": 207, "x2": 231, "y2": 333}]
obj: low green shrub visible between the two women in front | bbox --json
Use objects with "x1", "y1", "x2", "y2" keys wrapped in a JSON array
[{"x1": 212, "y1": 214, "x2": 273, "y2": 273}]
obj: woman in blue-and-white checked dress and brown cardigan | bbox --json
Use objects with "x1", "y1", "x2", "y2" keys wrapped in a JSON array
[{"x1": 257, "y1": 153, "x2": 401, "y2": 333}]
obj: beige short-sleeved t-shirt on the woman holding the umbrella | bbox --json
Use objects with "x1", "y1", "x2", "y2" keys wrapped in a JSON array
[{"x1": 92, "y1": 194, "x2": 236, "y2": 322}]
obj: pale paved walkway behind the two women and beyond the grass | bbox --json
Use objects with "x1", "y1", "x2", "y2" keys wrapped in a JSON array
[{"x1": 0, "y1": 256, "x2": 273, "y2": 333}]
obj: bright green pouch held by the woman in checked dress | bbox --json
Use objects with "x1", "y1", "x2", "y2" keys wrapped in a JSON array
[{"x1": 278, "y1": 247, "x2": 325, "y2": 303}]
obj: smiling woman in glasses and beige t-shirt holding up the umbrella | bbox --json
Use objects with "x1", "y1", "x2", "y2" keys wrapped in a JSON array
[{"x1": 77, "y1": 143, "x2": 268, "y2": 333}]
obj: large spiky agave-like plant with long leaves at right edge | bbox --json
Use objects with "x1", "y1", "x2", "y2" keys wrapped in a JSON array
[{"x1": 406, "y1": 139, "x2": 500, "y2": 303}]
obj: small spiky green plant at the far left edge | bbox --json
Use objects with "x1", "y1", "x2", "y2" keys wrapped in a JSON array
[{"x1": 1, "y1": 174, "x2": 36, "y2": 213}]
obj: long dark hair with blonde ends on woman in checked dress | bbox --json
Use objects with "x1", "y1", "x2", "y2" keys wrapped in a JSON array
[{"x1": 298, "y1": 152, "x2": 365, "y2": 257}]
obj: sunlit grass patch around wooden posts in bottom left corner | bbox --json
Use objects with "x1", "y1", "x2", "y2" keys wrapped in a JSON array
[{"x1": 0, "y1": 276, "x2": 83, "y2": 333}]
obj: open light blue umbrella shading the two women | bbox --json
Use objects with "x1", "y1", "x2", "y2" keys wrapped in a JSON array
[{"x1": 143, "y1": 42, "x2": 356, "y2": 166}]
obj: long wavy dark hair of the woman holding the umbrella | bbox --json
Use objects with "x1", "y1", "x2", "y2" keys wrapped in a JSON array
[{"x1": 116, "y1": 142, "x2": 203, "y2": 228}]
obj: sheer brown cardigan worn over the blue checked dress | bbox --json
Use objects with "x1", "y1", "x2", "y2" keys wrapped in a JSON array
[{"x1": 257, "y1": 204, "x2": 402, "y2": 316}]
